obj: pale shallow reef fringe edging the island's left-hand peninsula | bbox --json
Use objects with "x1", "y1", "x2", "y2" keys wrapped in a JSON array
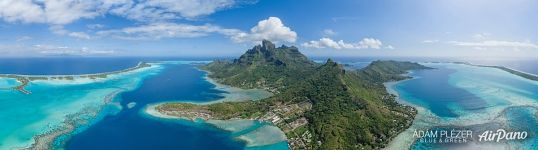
[{"x1": 143, "y1": 68, "x2": 287, "y2": 148}]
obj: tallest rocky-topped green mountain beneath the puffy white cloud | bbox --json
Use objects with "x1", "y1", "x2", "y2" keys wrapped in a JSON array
[{"x1": 203, "y1": 40, "x2": 316, "y2": 91}]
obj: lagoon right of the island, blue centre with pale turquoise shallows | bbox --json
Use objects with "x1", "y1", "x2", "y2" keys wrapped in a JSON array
[{"x1": 386, "y1": 63, "x2": 538, "y2": 150}]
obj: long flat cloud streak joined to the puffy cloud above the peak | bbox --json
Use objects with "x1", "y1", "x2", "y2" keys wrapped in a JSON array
[{"x1": 97, "y1": 17, "x2": 297, "y2": 43}]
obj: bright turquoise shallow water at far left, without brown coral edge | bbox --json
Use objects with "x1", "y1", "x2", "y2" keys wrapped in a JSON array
[{"x1": 0, "y1": 66, "x2": 157, "y2": 149}]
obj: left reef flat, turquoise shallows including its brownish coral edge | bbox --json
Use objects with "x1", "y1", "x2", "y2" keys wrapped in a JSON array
[{"x1": 0, "y1": 63, "x2": 161, "y2": 149}]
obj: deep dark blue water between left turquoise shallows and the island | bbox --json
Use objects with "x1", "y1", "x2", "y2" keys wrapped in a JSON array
[{"x1": 62, "y1": 65, "x2": 245, "y2": 150}]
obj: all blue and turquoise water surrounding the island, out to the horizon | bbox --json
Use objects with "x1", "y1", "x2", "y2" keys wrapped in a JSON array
[{"x1": 0, "y1": 58, "x2": 538, "y2": 149}]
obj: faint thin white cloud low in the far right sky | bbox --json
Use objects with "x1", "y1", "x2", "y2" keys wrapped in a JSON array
[{"x1": 448, "y1": 40, "x2": 538, "y2": 49}]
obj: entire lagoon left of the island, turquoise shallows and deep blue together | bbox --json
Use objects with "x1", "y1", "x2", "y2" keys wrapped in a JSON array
[{"x1": 0, "y1": 61, "x2": 288, "y2": 150}]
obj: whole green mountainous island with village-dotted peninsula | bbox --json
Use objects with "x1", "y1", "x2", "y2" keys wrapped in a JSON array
[{"x1": 151, "y1": 40, "x2": 431, "y2": 149}]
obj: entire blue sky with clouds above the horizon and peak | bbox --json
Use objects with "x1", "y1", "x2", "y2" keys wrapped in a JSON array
[{"x1": 0, "y1": 0, "x2": 538, "y2": 59}]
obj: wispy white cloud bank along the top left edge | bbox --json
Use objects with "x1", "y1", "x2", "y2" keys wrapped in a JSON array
[{"x1": 0, "y1": 0, "x2": 249, "y2": 39}]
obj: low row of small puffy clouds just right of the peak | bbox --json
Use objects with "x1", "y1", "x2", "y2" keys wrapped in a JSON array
[{"x1": 302, "y1": 38, "x2": 394, "y2": 49}]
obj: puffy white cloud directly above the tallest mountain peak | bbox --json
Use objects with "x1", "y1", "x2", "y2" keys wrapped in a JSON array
[{"x1": 231, "y1": 17, "x2": 297, "y2": 42}]
